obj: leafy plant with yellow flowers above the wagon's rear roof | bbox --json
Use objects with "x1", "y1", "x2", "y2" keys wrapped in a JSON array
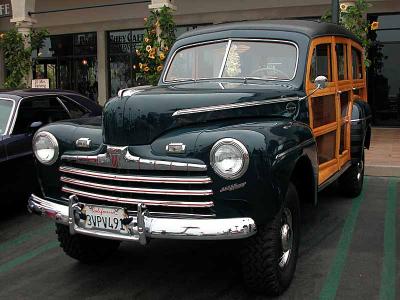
[{"x1": 321, "y1": 0, "x2": 379, "y2": 67}]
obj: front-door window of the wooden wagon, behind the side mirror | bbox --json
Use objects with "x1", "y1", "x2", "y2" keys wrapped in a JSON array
[{"x1": 310, "y1": 44, "x2": 332, "y2": 82}]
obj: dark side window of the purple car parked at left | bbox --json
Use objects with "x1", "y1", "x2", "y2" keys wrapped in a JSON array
[{"x1": 13, "y1": 96, "x2": 69, "y2": 134}]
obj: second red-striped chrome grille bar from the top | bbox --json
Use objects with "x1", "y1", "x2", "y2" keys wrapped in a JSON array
[{"x1": 61, "y1": 176, "x2": 213, "y2": 196}]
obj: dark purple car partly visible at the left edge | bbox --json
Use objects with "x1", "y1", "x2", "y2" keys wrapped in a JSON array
[{"x1": 0, "y1": 89, "x2": 102, "y2": 203}]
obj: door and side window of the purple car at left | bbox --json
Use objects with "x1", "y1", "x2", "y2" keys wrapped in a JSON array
[{"x1": 5, "y1": 96, "x2": 69, "y2": 196}]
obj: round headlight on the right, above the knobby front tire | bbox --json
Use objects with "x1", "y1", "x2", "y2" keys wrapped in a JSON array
[{"x1": 210, "y1": 138, "x2": 249, "y2": 179}]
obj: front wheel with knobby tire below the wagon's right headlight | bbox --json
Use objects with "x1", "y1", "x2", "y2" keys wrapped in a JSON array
[{"x1": 241, "y1": 183, "x2": 300, "y2": 296}]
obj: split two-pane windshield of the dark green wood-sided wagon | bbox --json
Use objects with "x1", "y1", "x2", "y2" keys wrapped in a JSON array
[{"x1": 165, "y1": 41, "x2": 297, "y2": 81}]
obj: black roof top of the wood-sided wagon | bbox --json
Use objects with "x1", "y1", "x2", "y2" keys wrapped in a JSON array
[{"x1": 178, "y1": 20, "x2": 360, "y2": 43}]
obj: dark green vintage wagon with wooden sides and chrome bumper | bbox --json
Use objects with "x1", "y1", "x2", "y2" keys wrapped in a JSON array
[{"x1": 29, "y1": 20, "x2": 370, "y2": 295}]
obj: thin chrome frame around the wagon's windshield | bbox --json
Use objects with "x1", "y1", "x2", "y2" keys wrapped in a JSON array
[{"x1": 162, "y1": 38, "x2": 300, "y2": 84}]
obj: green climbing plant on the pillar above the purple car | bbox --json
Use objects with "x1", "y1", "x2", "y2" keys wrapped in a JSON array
[{"x1": 0, "y1": 28, "x2": 48, "y2": 89}]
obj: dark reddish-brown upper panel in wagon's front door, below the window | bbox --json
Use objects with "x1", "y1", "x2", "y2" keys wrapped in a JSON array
[{"x1": 312, "y1": 95, "x2": 336, "y2": 128}]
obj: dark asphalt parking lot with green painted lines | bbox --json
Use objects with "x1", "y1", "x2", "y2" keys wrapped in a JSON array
[{"x1": 0, "y1": 177, "x2": 400, "y2": 299}]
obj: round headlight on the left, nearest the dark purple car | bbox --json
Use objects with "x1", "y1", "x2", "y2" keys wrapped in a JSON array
[{"x1": 32, "y1": 131, "x2": 59, "y2": 165}]
